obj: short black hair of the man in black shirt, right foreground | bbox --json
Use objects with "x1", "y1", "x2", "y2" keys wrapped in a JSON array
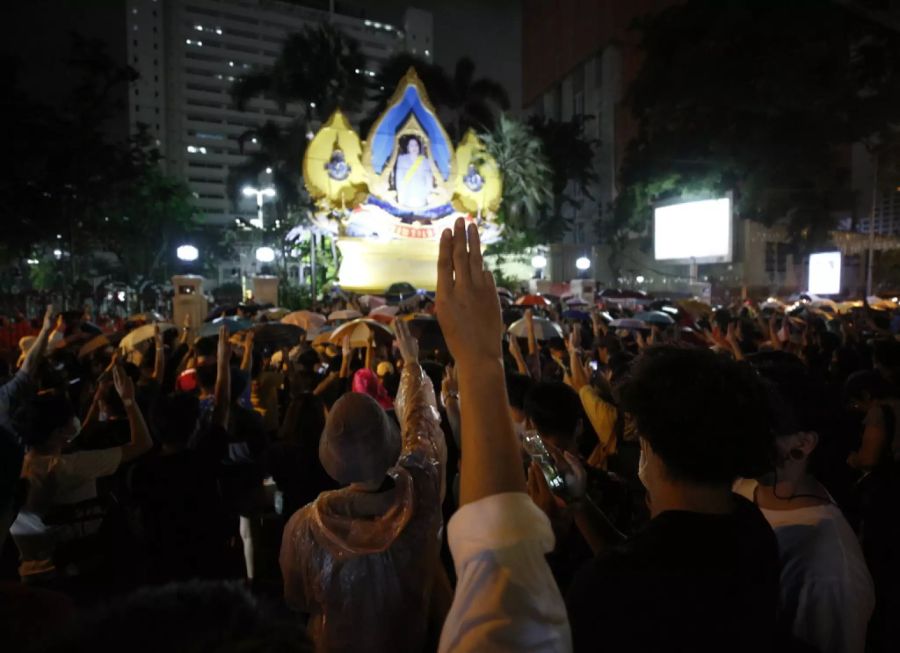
[{"x1": 620, "y1": 345, "x2": 773, "y2": 485}]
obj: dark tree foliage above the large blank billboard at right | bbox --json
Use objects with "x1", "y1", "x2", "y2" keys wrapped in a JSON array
[{"x1": 616, "y1": 0, "x2": 900, "y2": 247}]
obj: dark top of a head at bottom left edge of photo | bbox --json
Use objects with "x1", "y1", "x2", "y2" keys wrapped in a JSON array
[{"x1": 35, "y1": 581, "x2": 312, "y2": 653}]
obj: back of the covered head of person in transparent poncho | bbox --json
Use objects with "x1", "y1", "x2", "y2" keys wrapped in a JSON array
[{"x1": 319, "y1": 392, "x2": 400, "y2": 484}]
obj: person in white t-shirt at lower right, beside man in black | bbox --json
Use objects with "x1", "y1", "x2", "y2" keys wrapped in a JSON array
[{"x1": 734, "y1": 356, "x2": 875, "y2": 653}]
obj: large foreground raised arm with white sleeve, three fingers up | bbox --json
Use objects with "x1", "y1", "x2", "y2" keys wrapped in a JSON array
[{"x1": 437, "y1": 220, "x2": 572, "y2": 653}]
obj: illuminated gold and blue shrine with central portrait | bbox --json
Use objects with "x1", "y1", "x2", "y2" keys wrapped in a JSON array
[{"x1": 303, "y1": 68, "x2": 502, "y2": 292}]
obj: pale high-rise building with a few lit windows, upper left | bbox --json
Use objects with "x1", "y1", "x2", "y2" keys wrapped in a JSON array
[{"x1": 126, "y1": 0, "x2": 432, "y2": 224}]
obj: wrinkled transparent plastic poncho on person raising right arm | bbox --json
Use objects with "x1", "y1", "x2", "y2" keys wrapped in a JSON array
[{"x1": 280, "y1": 365, "x2": 447, "y2": 653}]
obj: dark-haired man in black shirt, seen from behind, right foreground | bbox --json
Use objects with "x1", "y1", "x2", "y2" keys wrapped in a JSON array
[{"x1": 567, "y1": 346, "x2": 779, "y2": 653}]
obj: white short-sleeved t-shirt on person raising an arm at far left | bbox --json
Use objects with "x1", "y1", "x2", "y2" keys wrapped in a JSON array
[{"x1": 9, "y1": 447, "x2": 122, "y2": 576}]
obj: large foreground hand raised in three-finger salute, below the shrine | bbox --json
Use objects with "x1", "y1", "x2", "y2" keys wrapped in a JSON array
[{"x1": 436, "y1": 219, "x2": 503, "y2": 368}]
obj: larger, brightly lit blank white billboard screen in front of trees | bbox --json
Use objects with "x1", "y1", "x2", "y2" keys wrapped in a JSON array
[{"x1": 653, "y1": 197, "x2": 731, "y2": 263}]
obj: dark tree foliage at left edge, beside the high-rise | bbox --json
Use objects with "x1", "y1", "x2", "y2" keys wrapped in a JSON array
[{"x1": 0, "y1": 34, "x2": 205, "y2": 288}]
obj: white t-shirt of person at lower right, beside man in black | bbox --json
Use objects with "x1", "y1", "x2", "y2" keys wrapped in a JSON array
[{"x1": 735, "y1": 480, "x2": 875, "y2": 653}]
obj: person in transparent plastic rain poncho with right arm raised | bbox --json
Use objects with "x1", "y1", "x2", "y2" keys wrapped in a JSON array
[{"x1": 280, "y1": 321, "x2": 447, "y2": 652}]
